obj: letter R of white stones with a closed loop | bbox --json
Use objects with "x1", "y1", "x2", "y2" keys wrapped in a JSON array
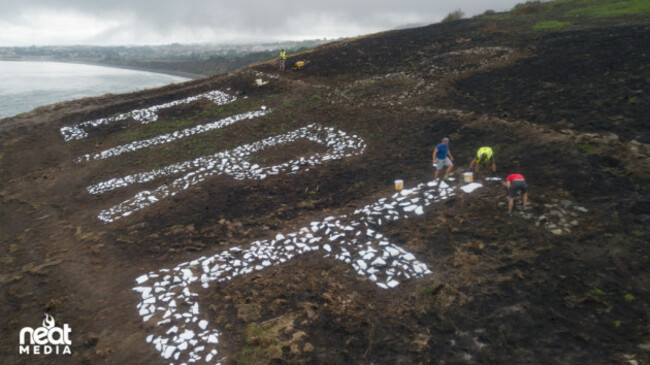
[{"x1": 91, "y1": 124, "x2": 366, "y2": 223}]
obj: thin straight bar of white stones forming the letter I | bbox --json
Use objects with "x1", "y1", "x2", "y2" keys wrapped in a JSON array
[{"x1": 75, "y1": 107, "x2": 271, "y2": 163}]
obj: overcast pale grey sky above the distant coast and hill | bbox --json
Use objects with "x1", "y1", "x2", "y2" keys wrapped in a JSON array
[{"x1": 0, "y1": 0, "x2": 523, "y2": 46}]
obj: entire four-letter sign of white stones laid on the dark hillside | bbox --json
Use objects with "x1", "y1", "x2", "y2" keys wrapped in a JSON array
[{"x1": 61, "y1": 91, "x2": 480, "y2": 364}]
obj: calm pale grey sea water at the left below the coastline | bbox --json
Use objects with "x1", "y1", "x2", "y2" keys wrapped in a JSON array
[{"x1": 0, "y1": 61, "x2": 189, "y2": 119}]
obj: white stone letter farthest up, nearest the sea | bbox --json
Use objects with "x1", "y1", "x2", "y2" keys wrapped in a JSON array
[{"x1": 61, "y1": 90, "x2": 237, "y2": 142}]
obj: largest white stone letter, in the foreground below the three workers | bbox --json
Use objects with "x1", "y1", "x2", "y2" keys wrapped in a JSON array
[{"x1": 133, "y1": 178, "x2": 481, "y2": 364}]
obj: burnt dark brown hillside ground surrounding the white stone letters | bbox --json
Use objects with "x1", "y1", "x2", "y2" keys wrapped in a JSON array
[{"x1": 0, "y1": 3, "x2": 650, "y2": 364}]
